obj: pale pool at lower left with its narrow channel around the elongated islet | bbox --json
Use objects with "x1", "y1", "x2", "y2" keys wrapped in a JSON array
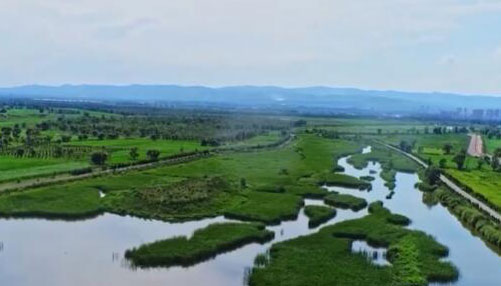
[{"x1": 0, "y1": 199, "x2": 367, "y2": 286}]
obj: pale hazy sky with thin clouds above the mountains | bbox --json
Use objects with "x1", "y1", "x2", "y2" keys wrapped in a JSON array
[{"x1": 0, "y1": 0, "x2": 501, "y2": 94}]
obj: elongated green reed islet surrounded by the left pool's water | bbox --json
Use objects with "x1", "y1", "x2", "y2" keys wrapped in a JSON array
[{"x1": 125, "y1": 223, "x2": 274, "y2": 267}]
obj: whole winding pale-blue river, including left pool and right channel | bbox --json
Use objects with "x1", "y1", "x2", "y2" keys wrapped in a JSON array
[{"x1": 0, "y1": 148, "x2": 501, "y2": 286}]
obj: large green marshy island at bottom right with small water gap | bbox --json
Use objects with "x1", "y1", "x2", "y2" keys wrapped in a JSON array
[{"x1": 250, "y1": 203, "x2": 458, "y2": 286}]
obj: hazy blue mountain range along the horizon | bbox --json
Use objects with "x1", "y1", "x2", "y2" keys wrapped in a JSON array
[{"x1": 0, "y1": 85, "x2": 501, "y2": 112}]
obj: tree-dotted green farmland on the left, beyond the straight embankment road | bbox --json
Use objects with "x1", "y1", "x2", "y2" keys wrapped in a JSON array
[{"x1": 0, "y1": 102, "x2": 292, "y2": 181}]
